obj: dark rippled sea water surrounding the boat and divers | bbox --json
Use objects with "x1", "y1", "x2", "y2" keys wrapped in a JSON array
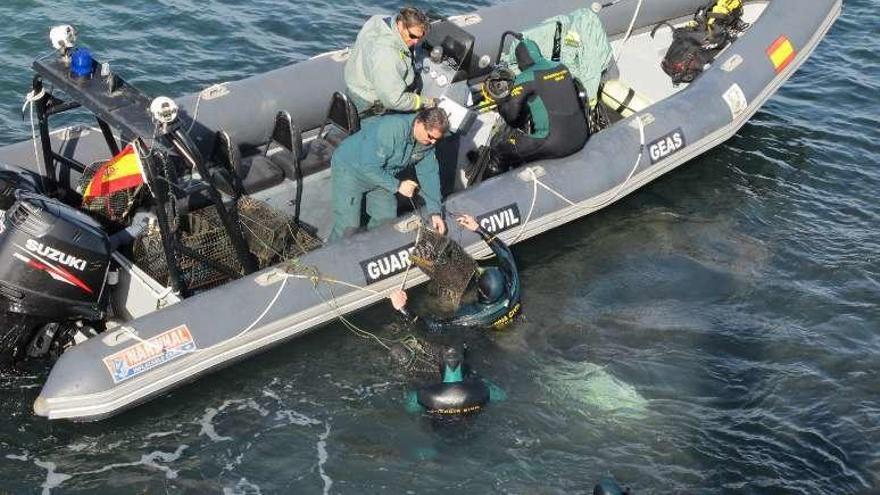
[{"x1": 0, "y1": 0, "x2": 880, "y2": 494}]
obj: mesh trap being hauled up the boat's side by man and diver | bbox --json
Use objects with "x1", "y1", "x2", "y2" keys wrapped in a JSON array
[{"x1": 410, "y1": 227, "x2": 477, "y2": 306}]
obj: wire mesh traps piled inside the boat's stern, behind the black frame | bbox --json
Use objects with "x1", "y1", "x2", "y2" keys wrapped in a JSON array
[{"x1": 133, "y1": 196, "x2": 321, "y2": 289}]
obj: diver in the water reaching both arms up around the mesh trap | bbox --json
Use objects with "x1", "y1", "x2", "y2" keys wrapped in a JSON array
[{"x1": 388, "y1": 215, "x2": 522, "y2": 333}]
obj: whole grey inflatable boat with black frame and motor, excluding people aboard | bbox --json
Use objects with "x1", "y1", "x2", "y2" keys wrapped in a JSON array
[{"x1": 0, "y1": 0, "x2": 841, "y2": 420}]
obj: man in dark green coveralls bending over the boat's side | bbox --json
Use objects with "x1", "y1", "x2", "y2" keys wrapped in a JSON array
[{"x1": 330, "y1": 108, "x2": 449, "y2": 241}]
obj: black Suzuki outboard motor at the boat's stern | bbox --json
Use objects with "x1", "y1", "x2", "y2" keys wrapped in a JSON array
[{"x1": 0, "y1": 192, "x2": 111, "y2": 364}]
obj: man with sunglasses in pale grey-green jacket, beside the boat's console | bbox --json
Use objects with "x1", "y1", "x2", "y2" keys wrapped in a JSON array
[{"x1": 345, "y1": 7, "x2": 434, "y2": 114}]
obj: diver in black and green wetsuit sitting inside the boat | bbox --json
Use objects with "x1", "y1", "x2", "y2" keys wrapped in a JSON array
[{"x1": 486, "y1": 39, "x2": 590, "y2": 174}]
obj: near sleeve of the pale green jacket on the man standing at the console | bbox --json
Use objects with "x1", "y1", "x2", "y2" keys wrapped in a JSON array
[{"x1": 369, "y1": 47, "x2": 422, "y2": 112}]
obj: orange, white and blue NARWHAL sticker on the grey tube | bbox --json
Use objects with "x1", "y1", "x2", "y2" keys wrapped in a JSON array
[{"x1": 104, "y1": 325, "x2": 196, "y2": 383}]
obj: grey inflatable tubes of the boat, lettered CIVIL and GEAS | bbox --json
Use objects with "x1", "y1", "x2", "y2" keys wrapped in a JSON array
[{"x1": 0, "y1": 0, "x2": 841, "y2": 420}]
